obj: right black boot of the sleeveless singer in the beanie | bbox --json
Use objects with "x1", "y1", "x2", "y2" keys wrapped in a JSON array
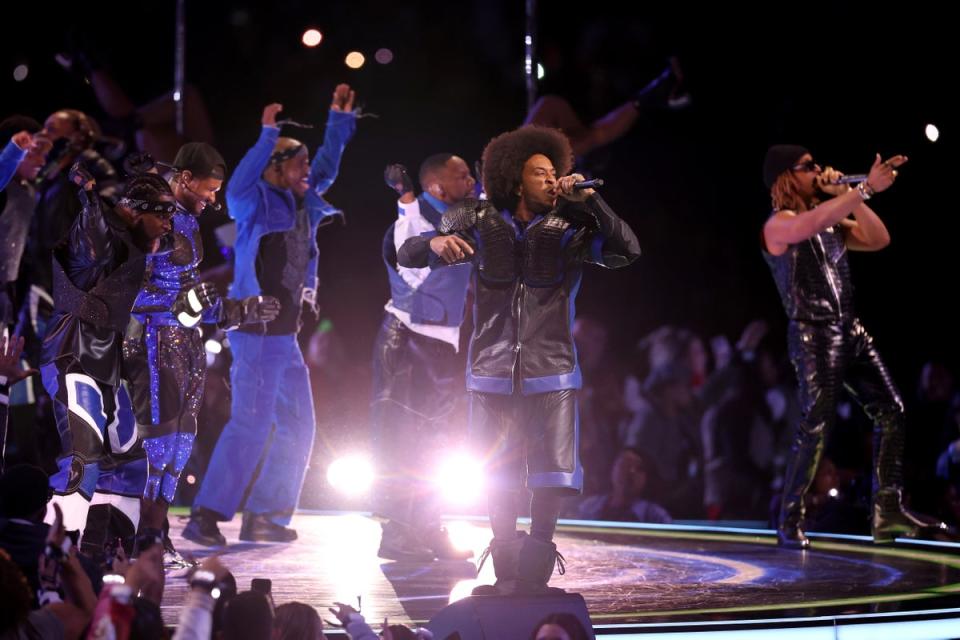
[{"x1": 871, "y1": 412, "x2": 949, "y2": 543}]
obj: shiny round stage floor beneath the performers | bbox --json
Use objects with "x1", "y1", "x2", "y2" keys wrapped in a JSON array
[{"x1": 163, "y1": 514, "x2": 960, "y2": 637}]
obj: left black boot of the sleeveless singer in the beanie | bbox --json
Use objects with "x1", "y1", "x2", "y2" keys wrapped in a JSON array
[{"x1": 777, "y1": 425, "x2": 823, "y2": 549}]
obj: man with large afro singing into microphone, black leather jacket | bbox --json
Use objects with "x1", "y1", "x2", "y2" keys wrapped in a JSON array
[{"x1": 398, "y1": 126, "x2": 640, "y2": 595}]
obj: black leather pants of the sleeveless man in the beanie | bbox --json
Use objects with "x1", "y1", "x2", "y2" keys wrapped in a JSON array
[{"x1": 780, "y1": 318, "x2": 905, "y2": 529}]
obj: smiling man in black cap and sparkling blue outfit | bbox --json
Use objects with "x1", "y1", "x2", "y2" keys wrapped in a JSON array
[{"x1": 123, "y1": 142, "x2": 278, "y2": 564}]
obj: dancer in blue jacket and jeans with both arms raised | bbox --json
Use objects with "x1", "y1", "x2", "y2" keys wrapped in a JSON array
[{"x1": 183, "y1": 84, "x2": 356, "y2": 546}]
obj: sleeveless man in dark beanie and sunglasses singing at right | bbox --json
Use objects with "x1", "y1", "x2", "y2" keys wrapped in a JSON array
[{"x1": 762, "y1": 145, "x2": 945, "y2": 548}]
